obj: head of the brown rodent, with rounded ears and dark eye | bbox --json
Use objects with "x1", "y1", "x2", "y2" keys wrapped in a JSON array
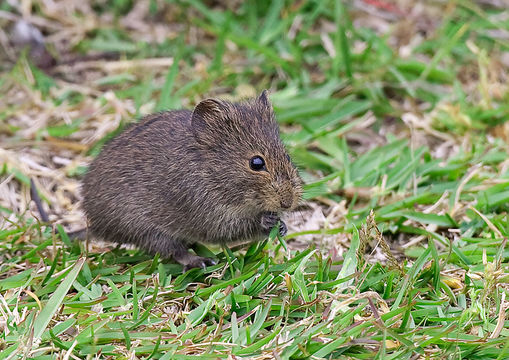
[{"x1": 191, "y1": 90, "x2": 302, "y2": 212}]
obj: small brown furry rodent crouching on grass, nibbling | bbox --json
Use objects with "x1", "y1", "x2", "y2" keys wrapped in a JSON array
[{"x1": 82, "y1": 90, "x2": 302, "y2": 269}]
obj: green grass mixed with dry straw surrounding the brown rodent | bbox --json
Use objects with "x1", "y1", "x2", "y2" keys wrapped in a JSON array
[{"x1": 0, "y1": 0, "x2": 509, "y2": 359}]
